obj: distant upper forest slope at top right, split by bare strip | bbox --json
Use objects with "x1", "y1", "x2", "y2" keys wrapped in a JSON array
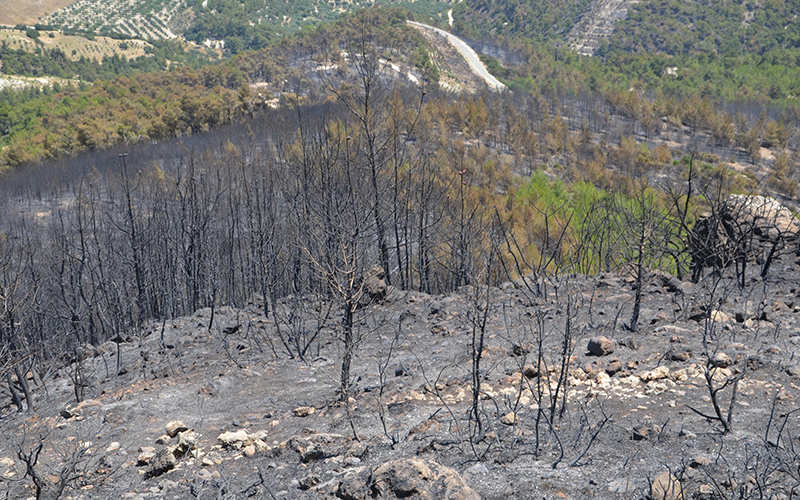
[{"x1": 454, "y1": 0, "x2": 800, "y2": 56}]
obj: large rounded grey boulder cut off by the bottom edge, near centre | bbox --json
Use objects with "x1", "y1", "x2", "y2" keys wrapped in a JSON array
[{"x1": 336, "y1": 458, "x2": 480, "y2": 500}]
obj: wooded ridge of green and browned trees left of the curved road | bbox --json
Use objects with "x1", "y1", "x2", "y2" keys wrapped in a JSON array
[{"x1": 0, "y1": 8, "x2": 433, "y2": 167}]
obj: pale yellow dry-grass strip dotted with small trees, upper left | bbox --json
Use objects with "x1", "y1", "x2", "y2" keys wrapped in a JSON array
[{"x1": 0, "y1": 28, "x2": 149, "y2": 61}]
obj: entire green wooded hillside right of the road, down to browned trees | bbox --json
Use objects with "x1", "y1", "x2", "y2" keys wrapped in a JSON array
[{"x1": 454, "y1": 0, "x2": 800, "y2": 106}]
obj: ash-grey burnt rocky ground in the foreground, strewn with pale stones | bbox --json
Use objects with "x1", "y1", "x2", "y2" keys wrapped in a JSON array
[{"x1": 0, "y1": 255, "x2": 800, "y2": 499}]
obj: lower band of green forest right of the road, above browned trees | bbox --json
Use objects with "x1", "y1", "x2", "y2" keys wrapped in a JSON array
[{"x1": 484, "y1": 40, "x2": 800, "y2": 102}]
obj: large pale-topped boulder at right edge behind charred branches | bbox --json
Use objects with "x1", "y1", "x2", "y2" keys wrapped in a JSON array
[{"x1": 689, "y1": 194, "x2": 800, "y2": 282}]
